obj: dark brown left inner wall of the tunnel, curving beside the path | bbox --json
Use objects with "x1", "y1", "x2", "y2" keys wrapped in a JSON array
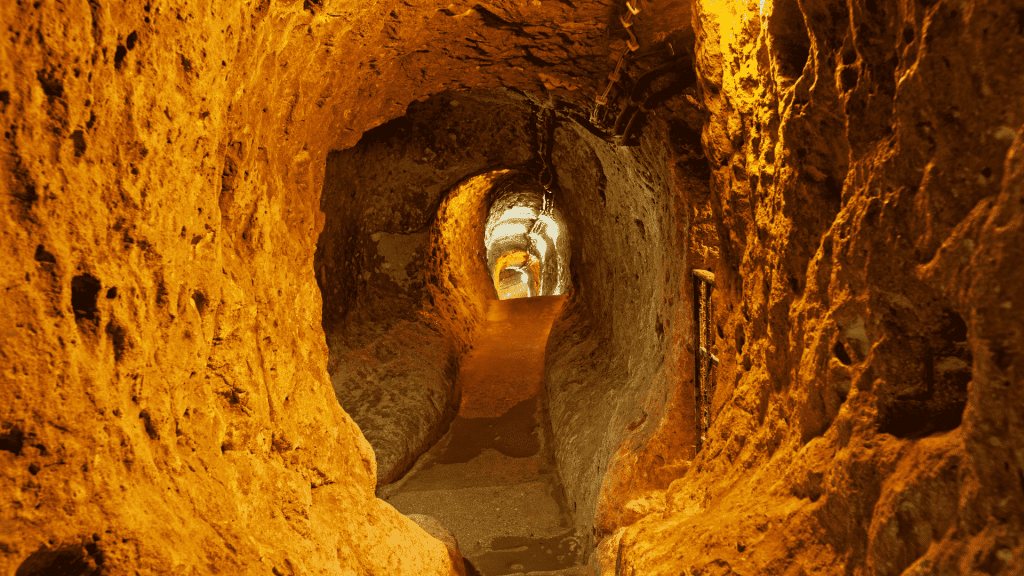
[{"x1": 315, "y1": 91, "x2": 532, "y2": 484}]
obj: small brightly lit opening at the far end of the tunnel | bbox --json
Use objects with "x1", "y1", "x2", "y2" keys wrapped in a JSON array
[{"x1": 483, "y1": 179, "x2": 569, "y2": 300}]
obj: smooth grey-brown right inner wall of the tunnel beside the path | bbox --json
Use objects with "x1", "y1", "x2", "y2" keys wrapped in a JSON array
[{"x1": 546, "y1": 113, "x2": 699, "y2": 544}]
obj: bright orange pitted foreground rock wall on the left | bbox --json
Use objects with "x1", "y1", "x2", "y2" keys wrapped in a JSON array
[{"x1": 0, "y1": 1, "x2": 577, "y2": 574}]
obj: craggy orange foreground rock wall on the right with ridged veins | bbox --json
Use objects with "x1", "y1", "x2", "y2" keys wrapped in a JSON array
[{"x1": 605, "y1": 1, "x2": 1024, "y2": 575}]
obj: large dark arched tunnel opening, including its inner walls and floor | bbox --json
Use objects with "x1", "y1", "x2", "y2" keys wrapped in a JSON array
[{"x1": 313, "y1": 89, "x2": 696, "y2": 576}]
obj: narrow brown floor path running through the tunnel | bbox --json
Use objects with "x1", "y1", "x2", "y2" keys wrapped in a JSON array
[{"x1": 379, "y1": 296, "x2": 581, "y2": 576}]
